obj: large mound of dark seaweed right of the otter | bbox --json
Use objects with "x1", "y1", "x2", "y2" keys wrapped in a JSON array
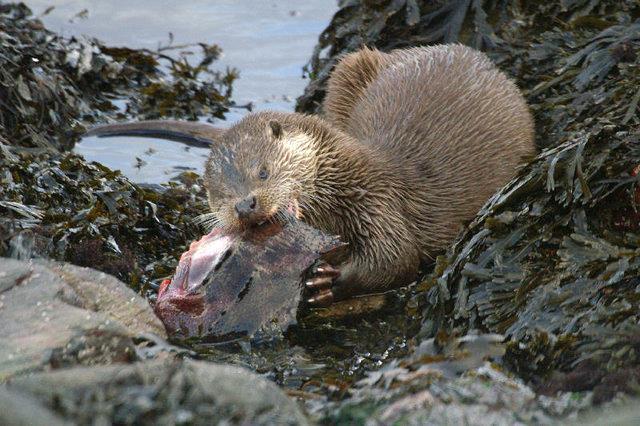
[{"x1": 424, "y1": 129, "x2": 640, "y2": 376}]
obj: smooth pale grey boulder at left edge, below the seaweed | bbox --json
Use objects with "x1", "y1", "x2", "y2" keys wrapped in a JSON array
[{"x1": 0, "y1": 258, "x2": 166, "y2": 380}]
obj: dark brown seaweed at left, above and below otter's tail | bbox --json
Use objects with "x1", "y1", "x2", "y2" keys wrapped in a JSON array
[{"x1": 0, "y1": 3, "x2": 237, "y2": 292}]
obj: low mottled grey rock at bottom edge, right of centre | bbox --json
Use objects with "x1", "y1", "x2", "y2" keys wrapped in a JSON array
[{"x1": 325, "y1": 362, "x2": 591, "y2": 425}]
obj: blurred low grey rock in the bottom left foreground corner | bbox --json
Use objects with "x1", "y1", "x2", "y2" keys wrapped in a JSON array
[{"x1": 0, "y1": 360, "x2": 307, "y2": 425}]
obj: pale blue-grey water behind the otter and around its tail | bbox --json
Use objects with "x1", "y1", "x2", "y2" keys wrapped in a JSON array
[{"x1": 25, "y1": 0, "x2": 337, "y2": 183}]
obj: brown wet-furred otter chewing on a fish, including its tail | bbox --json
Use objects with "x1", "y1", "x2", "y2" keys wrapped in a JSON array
[{"x1": 85, "y1": 44, "x2": 536, "y2": 305}]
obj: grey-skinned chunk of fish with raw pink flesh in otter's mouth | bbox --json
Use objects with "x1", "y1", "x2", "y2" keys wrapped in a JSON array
[{"x1": 155, "y1": 221, "x2": 343, "y2": 340}]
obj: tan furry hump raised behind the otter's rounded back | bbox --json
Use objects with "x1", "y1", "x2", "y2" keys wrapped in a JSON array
[{"x1": 323, "y1": 47, "x2": 387, "y2": 132}]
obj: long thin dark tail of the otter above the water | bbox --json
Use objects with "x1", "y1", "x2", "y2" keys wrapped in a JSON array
[{"x1": 84, "y1": 120, "x2": 225, "y2": 148}]
